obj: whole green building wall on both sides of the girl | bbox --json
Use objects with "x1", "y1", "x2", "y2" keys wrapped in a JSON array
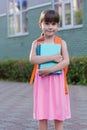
[{"x1": 0, "y1": 0, "x2": 87, "y2": 59}]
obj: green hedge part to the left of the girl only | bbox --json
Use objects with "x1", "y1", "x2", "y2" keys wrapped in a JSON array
[{"x1": 0, "y1": 60, "x2": 33, "y2": 82}]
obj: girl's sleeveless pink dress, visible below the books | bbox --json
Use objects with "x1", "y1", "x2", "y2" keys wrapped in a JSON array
[{"x1": 34, "y1": 71, "x2": 71, "y2": 121}]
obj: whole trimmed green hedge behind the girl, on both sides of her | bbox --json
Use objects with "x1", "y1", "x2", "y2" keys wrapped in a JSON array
[{"x1": 0, "y1": 57, "x2": 87, "y2": 85}]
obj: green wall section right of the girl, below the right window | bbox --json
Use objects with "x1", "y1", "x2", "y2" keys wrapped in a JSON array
[{"x1": 59, "y1": 27, "x2": 87, "y2": 56}]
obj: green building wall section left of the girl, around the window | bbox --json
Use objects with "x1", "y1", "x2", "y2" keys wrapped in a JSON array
[{"x1": 0, "y1": 6, "x2": 50, "y2": 59}]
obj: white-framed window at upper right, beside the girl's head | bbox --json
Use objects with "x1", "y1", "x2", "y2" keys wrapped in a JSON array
[{"x1": 54, "y1": 0, "x2": 83, "y2": 28}]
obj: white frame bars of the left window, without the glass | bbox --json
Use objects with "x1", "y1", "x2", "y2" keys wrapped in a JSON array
[{"x1": 7, "y1": 0, "x2": 29, "y2": 37}]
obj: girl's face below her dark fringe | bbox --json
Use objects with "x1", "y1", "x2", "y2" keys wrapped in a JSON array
[{"x1": 41, "y1": 21, "x2": 58, "y2": 37}]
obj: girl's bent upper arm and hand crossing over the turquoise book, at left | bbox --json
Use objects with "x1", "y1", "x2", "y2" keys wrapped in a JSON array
[{"x1": 29, "y1": 41, "x2": 61, "y2": 64}]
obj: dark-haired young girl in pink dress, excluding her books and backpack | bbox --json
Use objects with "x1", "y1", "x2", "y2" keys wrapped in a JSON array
[{"x1": 30, "y1": 10, "x2": 71, "y2": 130}]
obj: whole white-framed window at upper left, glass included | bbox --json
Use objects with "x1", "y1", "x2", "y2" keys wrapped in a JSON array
[{"x1": 8, "y1": 0, "x2": 28, "y2": 35}]
